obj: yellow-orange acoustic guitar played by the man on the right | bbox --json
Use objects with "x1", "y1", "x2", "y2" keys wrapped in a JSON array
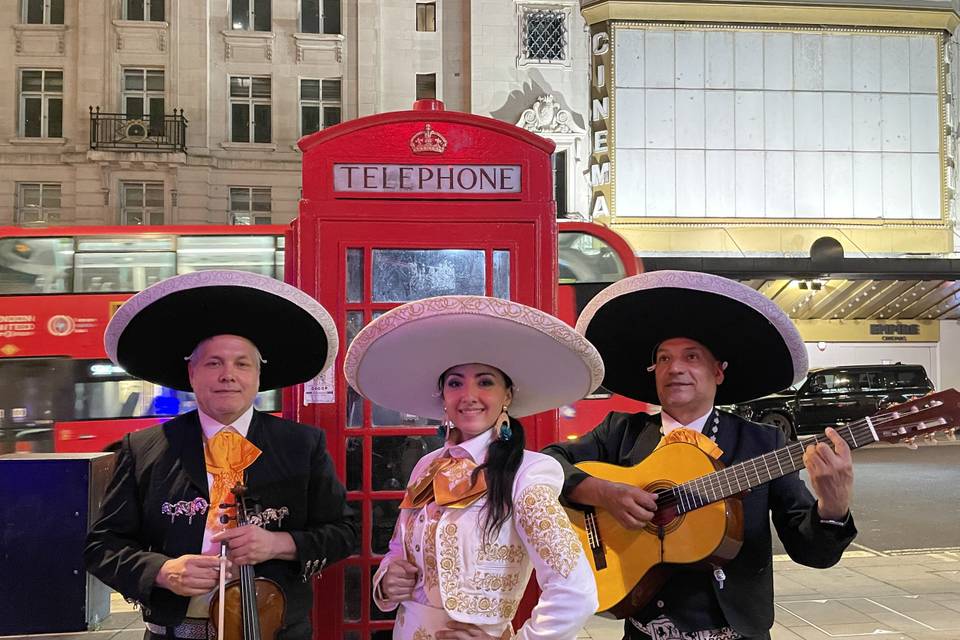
[{"x1": 568, "y1": 389, "x2": 960, "y2": 618}]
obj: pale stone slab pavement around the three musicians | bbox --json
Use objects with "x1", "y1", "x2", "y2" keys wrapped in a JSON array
[{"x1": 3, "y1": 544, "x2": 960, "y2": 640}]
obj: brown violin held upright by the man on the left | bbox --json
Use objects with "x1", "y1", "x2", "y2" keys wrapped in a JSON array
[{"x1": 210, "y1": 484, "x2": 287, "y2": 640}]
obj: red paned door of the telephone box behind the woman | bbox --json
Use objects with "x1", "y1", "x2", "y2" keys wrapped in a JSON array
[{"x1": 304, "y1": 222, "x2": 537, "y2": 640}]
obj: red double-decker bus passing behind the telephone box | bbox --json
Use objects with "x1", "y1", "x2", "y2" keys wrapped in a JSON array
[{"x1": 0, "y1": 221, "x2": 640, "y2": 453}]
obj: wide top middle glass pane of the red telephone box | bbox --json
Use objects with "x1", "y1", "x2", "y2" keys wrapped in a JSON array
[{"x1": 372, "y1": 249, "x2": 486, "y2": 302}]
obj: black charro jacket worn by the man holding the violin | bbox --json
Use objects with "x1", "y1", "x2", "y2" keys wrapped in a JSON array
[{"x1": 84, "y1": 411, "x2": 358, "y2": 639}]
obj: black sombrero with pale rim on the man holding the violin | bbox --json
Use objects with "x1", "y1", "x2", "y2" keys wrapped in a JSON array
[{"x1": 103, "y1": 270, "x2": 338, "y2": 391}]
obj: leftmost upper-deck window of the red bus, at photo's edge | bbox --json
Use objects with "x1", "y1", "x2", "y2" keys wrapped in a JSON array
[{"x1": 0, "y1": 238, "x2": 73, "y2": 294}]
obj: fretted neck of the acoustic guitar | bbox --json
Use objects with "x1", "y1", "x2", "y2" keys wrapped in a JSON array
[{"x1": 657, "y1": 420, "x2": 878, "y2": 513}]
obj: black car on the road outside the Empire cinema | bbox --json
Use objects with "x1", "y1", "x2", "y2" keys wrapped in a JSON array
[{"x1": 733, "y1": 363, "x2": 933, "y2": 439}]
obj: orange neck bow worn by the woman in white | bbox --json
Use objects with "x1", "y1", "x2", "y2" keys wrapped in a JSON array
[{"x1": 400, "y1": 458, "x2": 487, "y2": 509}]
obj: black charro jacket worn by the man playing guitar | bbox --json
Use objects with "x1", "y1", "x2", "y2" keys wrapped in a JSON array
[{"x1": 543, "y1": 411, "x2": 857, "y2": 638}]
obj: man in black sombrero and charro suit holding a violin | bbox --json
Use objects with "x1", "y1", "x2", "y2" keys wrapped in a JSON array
[{"x1": 84, "y1": 271, "x2": 357, "y2": 640}]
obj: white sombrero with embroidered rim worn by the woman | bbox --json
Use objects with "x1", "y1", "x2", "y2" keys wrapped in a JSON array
[{"x1": 344, "y1": 296, "x2": 603, "y2": 419}]
